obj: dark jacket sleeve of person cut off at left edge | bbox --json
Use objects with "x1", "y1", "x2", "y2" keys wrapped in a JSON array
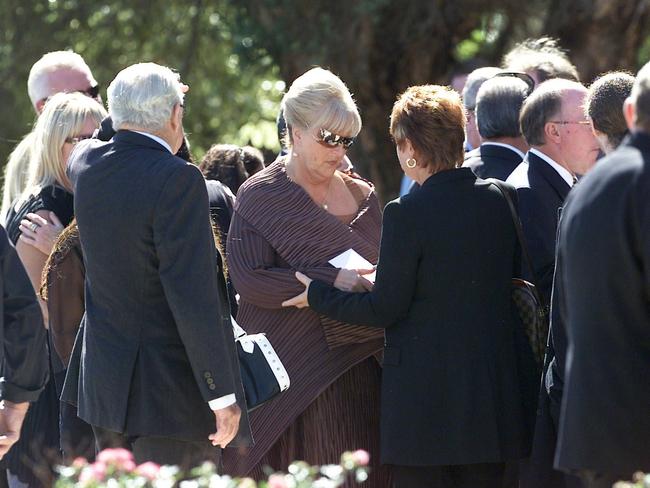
[{"x1": 0, "y1": 226, "x2": 49, "y2": 403}]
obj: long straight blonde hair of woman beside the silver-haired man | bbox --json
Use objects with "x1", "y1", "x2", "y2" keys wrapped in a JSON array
[{"x1": 21, "y1": 93, "x2": 106, "y2": 200}]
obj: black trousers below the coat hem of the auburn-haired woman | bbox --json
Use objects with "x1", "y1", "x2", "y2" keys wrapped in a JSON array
[{"x1": 391, "y1": 463, "x2": 517, "y2": 488}]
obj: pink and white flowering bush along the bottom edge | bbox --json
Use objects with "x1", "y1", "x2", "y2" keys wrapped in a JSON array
[{"x1": 54, "y1": 449, "x2": 370, "y2": 488}]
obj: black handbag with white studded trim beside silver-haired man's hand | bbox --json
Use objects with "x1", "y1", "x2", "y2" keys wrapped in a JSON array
[{"x1": 232, "y1": 318, "x2": 290, "y2": 412}]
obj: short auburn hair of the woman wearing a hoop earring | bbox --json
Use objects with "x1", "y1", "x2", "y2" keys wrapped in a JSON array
[{"x1": 390, "y1": 85, "x2": 465, "y2": 173}]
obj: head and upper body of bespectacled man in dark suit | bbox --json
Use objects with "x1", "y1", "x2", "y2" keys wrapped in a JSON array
[{"x1": 506, "y1": 79, "x2": 599, "y2": 304}]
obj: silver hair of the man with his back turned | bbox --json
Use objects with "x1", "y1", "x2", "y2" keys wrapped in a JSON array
[{"x1": 107, "y1": 63, "x2": 183, "y2": 131}]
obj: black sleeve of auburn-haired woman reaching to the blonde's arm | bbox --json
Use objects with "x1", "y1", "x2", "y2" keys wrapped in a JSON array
[{"x1": 308, "y1": 200, "x2": 421, "y2": 328}]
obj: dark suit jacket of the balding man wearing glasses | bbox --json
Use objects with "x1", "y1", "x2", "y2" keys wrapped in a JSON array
[{"x1": 506, "y1": 152, "x2": 571, "y2": 305}]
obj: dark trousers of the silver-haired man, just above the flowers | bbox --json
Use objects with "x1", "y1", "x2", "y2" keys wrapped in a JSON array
[{"x1": 93, "y1": 425, "x2": 221, "y2": 472}]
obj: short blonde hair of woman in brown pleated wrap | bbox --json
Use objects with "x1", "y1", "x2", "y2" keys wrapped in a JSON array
[{"x1": 282, "y1": 68, "x2": 361, "y2": 145}]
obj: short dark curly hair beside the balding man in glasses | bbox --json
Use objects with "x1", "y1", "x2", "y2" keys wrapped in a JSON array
[{"x1": 585, "y1": 71, "x2": 634, "y2": 147}]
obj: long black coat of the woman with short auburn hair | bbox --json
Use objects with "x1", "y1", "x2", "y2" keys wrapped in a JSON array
[{"x1": 309, "y1": 168, "x2": 527, "y2": 466}]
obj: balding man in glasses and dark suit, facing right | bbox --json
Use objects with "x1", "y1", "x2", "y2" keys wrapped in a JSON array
[{"x1": 507, "y1": 79, "x2": 598, "y2": 488}]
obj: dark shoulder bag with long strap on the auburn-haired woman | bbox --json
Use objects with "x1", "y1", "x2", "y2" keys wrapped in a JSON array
[{"x1": 487, "y1": 178, "x2": 549, "y2": 370}]
